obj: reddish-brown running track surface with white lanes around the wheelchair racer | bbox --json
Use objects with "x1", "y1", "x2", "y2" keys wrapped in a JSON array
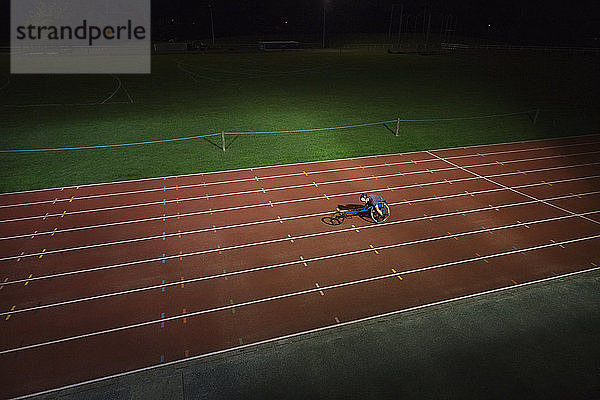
[{"x1": 0, "y1": 135, "x2": 600, "y2": 398}]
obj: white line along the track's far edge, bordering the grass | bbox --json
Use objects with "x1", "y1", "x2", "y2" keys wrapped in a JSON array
[{"x1": 0, "y1": 134, "x2": 598, "y2": 197}]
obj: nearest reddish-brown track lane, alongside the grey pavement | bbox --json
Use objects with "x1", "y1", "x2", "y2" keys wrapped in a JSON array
[{"x1": 0, "y1": 236, "x2": 596, "y2": 395}]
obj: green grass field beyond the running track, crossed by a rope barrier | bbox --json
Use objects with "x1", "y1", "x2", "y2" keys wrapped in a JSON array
[{"x1": 0, "y1": 51, "x2": 600, "y2": 192}]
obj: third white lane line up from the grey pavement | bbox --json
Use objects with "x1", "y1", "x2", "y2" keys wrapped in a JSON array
[{"x1": 5, "y1": 211, "x2": 600, "y2": 316}]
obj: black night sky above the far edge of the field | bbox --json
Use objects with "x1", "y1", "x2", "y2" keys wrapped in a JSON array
[{"x1": 0, "y1": 0, "x2": 600, "y2": 46}]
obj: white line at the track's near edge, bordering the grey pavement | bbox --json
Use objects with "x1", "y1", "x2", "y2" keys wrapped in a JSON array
[{"x1": 13, "y1": 267, "x2": 600, "y2": 400}]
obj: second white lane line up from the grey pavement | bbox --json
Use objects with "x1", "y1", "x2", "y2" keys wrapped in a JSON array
[{"x1": 0, "y1": 235, "x2": 600, "y2": 355}]
